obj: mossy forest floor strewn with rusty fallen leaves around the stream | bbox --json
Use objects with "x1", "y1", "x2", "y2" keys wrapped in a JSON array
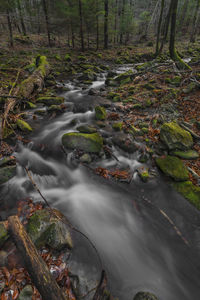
[{"x1": 0, "y1": 37, "x2": 200, "y2": 300}]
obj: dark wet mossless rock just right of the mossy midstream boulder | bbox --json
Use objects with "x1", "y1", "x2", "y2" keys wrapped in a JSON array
[{"x1": 112, "y1": 133, "x2": 138, "y2": 153}]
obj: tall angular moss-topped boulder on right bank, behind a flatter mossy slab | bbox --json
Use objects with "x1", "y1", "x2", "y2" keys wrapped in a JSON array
[{"x1": 160, "y1": 122, "x2": 193, "y2": 150}]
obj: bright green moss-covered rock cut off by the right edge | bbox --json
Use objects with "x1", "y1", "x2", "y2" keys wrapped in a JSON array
[{"x1": 173, "y1": 181, "x2": 200, "y2": 210}]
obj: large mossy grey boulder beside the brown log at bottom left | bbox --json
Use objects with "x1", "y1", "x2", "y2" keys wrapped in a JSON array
[{"x1": 27, "y1": 209, "x2": 73, "y2": 250}]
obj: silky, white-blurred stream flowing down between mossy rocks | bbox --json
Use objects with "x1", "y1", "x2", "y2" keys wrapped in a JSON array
[{"x1": 1, "y1": 68, "x2": 200, "y2": 300}]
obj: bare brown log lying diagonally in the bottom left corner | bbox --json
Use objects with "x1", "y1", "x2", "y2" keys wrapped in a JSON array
[{"x1": 8, "y1": 216, "x2": 67, "y2": 300}]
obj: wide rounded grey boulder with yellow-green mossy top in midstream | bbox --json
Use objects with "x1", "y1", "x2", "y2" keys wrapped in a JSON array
[{"x1": 62, "y1": 132, "x2": 103, "y2": 153}]
